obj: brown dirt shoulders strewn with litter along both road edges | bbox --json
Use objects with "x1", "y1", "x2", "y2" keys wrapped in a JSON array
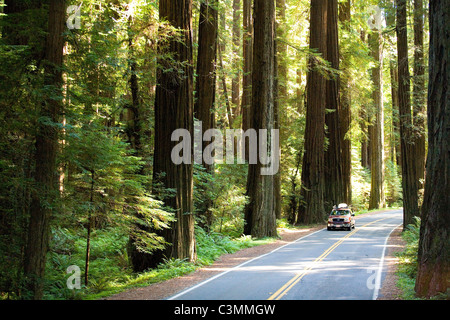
[{"x1": 105, "y1": 211, "x2": 405, "y2": 300}]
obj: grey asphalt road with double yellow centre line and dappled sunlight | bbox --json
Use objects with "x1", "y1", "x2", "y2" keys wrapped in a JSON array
[{"x1": 169, "y1": 210, "x2": 402, "y2": 300}]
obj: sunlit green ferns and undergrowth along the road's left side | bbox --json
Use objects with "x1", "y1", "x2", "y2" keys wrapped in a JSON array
[{"x1": 45, "y1": 228, "x2": 276, "y2": 300}]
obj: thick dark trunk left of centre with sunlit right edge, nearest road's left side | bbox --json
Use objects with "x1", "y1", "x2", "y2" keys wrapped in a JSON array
[{"x1": 129, "y1": 0, "x2": 196, "y2": 271}]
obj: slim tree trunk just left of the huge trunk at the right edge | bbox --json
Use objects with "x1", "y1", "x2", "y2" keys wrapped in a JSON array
[{"x1": 413, "y1": 0, "x2": 426, "y2": 188}]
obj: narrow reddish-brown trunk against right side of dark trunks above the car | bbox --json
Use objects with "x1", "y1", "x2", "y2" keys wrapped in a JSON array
[{"x1": 339, "y1": 0, "x2": 352, "y2": 203}]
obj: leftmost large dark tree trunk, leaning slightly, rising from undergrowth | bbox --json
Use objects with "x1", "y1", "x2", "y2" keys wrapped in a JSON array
[{"x1": 24, "y1": 0, "x2": 65, "y2": 299}]
